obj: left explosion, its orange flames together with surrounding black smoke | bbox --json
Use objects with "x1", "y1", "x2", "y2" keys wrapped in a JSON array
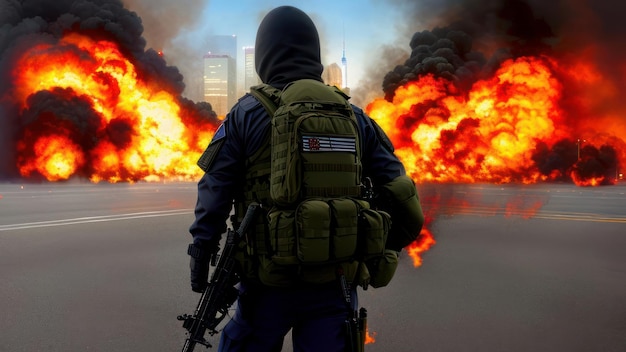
[{"x1": 0, "y1": 0, "x2": 218, "y2": 182}]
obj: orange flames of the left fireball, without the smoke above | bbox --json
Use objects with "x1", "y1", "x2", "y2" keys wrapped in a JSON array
[{"x1": 13, "y1": 33, "x2": 215, "y2": 182}]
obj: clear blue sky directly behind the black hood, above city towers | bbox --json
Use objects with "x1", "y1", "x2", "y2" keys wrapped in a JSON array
[{"x1": 193, "y1": 0, "x2": 402, "y2": 89}]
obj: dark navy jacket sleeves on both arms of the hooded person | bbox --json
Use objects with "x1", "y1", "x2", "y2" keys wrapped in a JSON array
[{"x1": 189, "y1": 94, "x2": 405, "y2": 244}]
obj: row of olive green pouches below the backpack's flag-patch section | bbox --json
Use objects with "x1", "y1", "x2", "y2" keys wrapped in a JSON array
[{"x1": 259, "y1": 198, "x2": 362, "y2": 286}]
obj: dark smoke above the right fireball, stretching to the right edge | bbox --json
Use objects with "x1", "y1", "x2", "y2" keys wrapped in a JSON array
[{"x1": 382, "y1": 0, "x2": 626, "y2": 106}]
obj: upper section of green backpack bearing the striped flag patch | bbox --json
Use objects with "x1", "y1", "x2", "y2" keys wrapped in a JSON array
[{"x1": 268, "y1": 80, "x2": 362, "y2": 206}]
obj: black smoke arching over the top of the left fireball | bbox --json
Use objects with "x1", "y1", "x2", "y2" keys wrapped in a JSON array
[{"x1": 0, "y1": 0, "x2": 185, "y2": 93}]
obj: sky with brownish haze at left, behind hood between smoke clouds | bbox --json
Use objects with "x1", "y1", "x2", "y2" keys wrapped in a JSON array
[{"x1": 129, "y1": 0, "x2": 410, "y2": 104}]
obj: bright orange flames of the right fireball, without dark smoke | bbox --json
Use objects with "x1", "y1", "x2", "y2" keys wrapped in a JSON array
[{"x1": 367, "y1": 57, "x2": 567, "y2": 183}]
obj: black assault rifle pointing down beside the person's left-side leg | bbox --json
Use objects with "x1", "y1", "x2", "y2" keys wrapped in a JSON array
[{"x1": 177, "y1": 203, "x2": 259, "y2": 352}]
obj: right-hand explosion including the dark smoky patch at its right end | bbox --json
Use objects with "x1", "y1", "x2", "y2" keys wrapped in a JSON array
[{"x1": 367, "y1": 38, "x2": 626, "y2": 186}]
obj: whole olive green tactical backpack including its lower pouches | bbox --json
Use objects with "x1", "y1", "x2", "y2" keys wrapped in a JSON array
[{"x1": 246, "y1": 79, "x2": 390, "y2": 286}]
